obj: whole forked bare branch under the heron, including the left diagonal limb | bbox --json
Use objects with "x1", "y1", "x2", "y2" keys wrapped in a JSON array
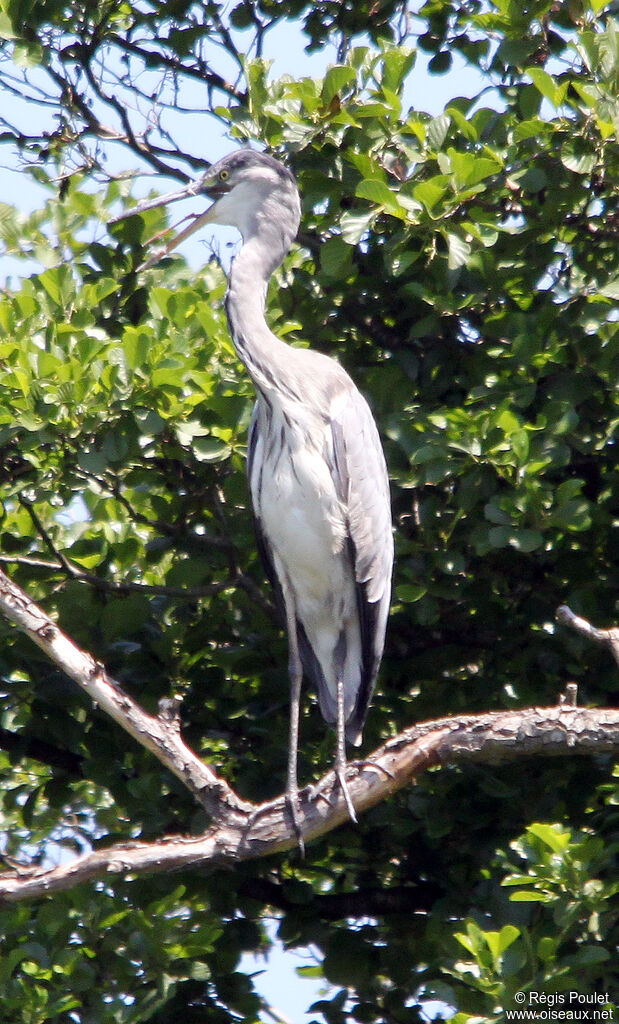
[{"x1": 0, "y1": 570, "x2": 619, "y2": 902}]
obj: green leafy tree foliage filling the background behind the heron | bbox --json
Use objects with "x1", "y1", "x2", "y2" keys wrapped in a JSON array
[{"x1": 0, "y1": 0, "x2": 619, "y2": 1024}]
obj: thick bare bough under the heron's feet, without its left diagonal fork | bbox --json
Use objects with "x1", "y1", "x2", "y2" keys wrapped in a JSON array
[{"x1": 0, "y1": 706, "x2": 619, "y2": 902}]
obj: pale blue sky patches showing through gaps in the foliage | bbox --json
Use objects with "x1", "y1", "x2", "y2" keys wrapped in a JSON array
[{"x1": 0, "y1": 12, "x2": 487, "y2": 1024}]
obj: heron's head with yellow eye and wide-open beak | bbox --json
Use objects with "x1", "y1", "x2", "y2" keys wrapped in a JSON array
[{"x1": 113, "y1": 150, "x2": 300, "y2": 263}]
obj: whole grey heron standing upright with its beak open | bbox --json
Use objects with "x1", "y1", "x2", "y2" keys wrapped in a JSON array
[{"x1": 118, "y1": 150, "x2": 394, "y2": 848}]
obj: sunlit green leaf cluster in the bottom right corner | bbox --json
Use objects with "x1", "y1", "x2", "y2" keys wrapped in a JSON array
[{"x1": 437, "y1": 822, "x2": 617, "y2": 1020}]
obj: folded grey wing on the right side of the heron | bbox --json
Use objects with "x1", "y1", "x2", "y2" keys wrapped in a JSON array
[{"x1": 331, "y1": 386, "x2": 394, "y2": 742}]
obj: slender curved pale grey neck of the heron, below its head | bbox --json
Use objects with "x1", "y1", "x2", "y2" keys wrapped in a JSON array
[{"x1": 225, "y1": 236, "x2": 294, "y2": 395}]
